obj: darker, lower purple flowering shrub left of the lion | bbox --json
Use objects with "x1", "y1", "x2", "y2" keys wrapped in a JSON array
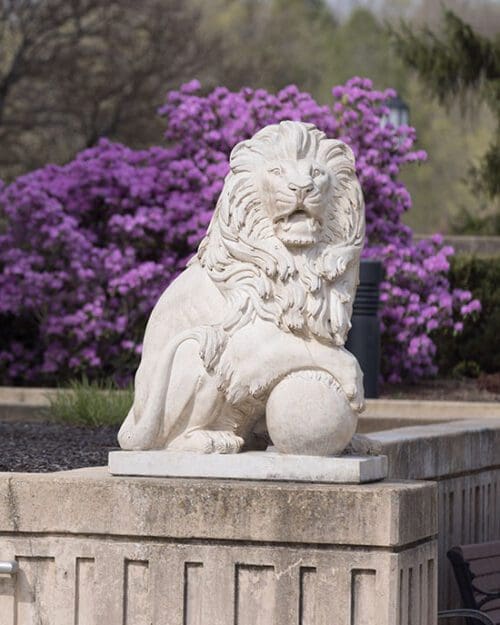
[{"x1": 0, "y1": 140, "x2": 181, "y2": 383}]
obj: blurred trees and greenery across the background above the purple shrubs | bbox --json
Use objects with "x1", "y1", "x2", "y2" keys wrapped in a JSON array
[{"x1": 0, "y1": 0, "x2": 500, "y2": 233}]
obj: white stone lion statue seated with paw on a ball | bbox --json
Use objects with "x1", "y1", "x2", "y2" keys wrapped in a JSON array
[{"x1": 119, "y1": 121, "x2": 365, "y2": 455}]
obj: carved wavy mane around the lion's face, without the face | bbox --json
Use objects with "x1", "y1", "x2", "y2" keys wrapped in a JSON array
[{"x1": 198, "y1": 121, "x2": 365, "y2": 345}]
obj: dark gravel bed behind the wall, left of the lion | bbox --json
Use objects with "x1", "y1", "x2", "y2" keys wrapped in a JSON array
[{"x1": 0, "y1": 422, "x2": 118, "y2": 473}]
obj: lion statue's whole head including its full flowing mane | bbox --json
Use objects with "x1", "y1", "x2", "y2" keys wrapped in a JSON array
[{"x1": 198, "y1": 121, "x2": 364, "y2": 343}]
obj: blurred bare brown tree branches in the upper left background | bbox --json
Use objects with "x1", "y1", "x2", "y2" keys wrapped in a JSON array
[{"x1": 0, "y1": 0, "x2": 220, "y2": 181}]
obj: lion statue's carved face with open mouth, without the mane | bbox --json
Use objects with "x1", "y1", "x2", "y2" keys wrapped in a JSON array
[{"x1": 255, "y1": 157, "x2": 334, "y2": 247}]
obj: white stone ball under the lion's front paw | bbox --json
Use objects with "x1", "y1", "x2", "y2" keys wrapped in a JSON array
[{"x1": 266, "y1": 370, "x2": 358, "y2": 456}]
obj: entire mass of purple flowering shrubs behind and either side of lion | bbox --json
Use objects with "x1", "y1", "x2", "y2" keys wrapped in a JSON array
[{"x1": 0, "y1": 78, "x2": 480, "y2": 383}]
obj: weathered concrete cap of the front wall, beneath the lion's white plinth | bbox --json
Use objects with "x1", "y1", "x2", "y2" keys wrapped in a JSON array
[{"x1": 0, "y1": 467, "x2": 436, "y2": 547}]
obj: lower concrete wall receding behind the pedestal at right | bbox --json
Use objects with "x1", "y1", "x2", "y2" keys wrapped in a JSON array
[{"x1": 370, "y1": 418, "x2": 500, "y2": 609}]
